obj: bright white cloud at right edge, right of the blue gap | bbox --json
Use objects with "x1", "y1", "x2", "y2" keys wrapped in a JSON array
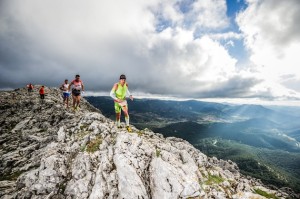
[{"x1": 236, "y1": 0, "x2": 300, "y2": 97}]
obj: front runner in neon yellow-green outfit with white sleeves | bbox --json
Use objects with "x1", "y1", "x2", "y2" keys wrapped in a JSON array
[{"x1": 110, "y1": 74, "x2": 133, "y2": 132}]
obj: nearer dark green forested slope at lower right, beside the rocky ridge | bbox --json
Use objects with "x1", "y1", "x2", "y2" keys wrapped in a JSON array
[{"x1": 194, "y1": 138, "x2": 300, "y2": 192}]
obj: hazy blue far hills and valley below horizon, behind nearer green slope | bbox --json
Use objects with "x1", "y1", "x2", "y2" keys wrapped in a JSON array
[{"x1": 86, "y1": 97, "x2": 300, "y2": 145}]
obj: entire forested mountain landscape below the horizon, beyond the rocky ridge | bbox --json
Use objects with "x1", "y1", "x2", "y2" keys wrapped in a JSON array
[{"x1": 86, "y1": 97, "x2": 300, "y2": 192}]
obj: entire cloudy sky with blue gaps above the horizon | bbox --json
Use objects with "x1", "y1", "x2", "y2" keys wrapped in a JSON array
[{"x1": 0, "y1": 0, "x2": 300, "y2": 105}]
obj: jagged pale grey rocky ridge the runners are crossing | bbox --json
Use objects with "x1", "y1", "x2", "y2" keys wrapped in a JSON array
[{"x1": 0, "y1": 88, "x2": 296, "y2": 199}]
